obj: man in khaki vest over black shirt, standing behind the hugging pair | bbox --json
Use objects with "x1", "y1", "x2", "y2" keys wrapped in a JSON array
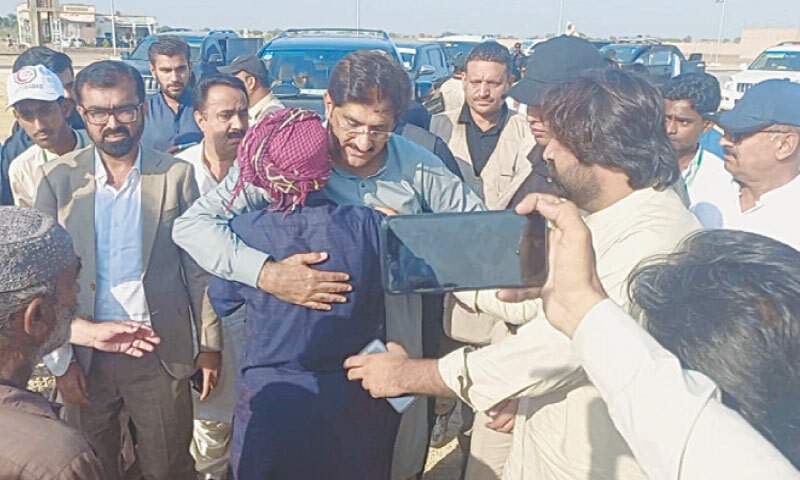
[{"x1": 431, "y1": 42, "x2": 536, "y2": 480}]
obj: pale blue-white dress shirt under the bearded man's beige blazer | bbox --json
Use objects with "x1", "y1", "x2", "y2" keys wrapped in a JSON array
[{"x1": 94, "y1": 147, "x2": 150, "y2": 323}]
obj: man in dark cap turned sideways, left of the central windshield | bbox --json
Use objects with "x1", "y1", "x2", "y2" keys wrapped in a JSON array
[{"x1": 217, "y1": 55, "x2": 283, "y2": 125}]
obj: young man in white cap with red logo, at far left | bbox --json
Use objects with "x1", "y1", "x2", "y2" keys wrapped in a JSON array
[{"x1": 6, "y1": 65, "x2": 90, "y2": 207}]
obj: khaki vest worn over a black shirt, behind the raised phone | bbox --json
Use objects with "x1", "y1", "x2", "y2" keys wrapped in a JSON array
[{"x1": 431, "y1": 107, "x2": 536, "y2": 345}]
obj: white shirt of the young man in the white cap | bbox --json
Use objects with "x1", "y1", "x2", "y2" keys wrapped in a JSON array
[{"x1": 8, "y1": 130, "x2": 91, "y2": 207}]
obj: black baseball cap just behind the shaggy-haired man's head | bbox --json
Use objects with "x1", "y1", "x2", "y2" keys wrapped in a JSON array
[{"x1": 508, "y1": 35, "x2": 607, "y2": 105}]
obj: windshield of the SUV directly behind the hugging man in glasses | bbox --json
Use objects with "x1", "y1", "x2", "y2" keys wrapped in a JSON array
[{"x1": 261, "y1": 50, "x2": 395, "y2": 95}]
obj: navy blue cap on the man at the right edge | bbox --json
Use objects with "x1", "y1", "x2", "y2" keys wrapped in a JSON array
[{"x1": 708, "y1": 79, "x2": 800, "y2": 135}]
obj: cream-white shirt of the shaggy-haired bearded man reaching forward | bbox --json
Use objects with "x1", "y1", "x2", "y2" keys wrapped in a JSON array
[{"x1": 438, "y1": 189, "x2": 700, "y2": 480}]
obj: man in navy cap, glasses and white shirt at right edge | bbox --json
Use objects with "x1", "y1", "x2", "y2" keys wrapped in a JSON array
[{"x1": 708, "y1": 80, "x2": 800, "y2": 250}]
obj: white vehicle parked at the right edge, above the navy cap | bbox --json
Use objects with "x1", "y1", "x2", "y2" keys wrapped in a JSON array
[{"x1": 720, "y1": 41, "x2": 800, "y2": 110}]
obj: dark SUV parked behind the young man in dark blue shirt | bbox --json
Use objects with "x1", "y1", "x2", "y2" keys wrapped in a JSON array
[{"x1": 122, "y1": 30, "x2": 264, "y2": 94}]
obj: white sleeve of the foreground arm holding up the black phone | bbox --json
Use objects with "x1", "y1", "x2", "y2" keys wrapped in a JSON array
[{"x1": 572, "y1": 300, "x2": 800, "y2": 480}]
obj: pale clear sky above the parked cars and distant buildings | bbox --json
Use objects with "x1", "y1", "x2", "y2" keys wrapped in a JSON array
[{"x1": 0, "y1": 0, "x2": 800, "y2": 39}]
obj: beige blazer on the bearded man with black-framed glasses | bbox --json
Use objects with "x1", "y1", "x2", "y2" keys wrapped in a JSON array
[{"x1": 36, "y1": 146, "x2": 222, "y2": 378}]
